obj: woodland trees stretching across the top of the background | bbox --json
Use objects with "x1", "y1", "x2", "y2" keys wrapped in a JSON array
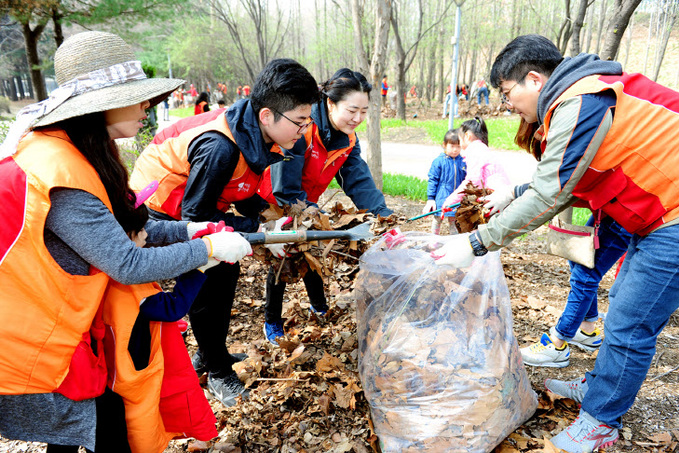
[{"x1": 0, "y1": 0, "x2": 679, "y2": 187}]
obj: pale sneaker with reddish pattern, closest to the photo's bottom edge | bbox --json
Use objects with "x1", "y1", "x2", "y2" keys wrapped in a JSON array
[{"x1": 551, "y1": 411, "x2": 618, "y2": 453}]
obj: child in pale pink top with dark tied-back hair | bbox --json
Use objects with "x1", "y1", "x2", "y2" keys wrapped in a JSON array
[{"x1": 444, "y1": 116, "x2": 511, "y2": 206}]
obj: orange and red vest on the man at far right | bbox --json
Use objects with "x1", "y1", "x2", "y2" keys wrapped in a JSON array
[{"x1": 544, "y1": 74, "x2": 679, "y2": 236}]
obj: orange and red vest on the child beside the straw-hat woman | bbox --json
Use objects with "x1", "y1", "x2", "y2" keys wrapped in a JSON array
[{"x1": 103, "y1": 280, "x2": 217, "y2": 453}]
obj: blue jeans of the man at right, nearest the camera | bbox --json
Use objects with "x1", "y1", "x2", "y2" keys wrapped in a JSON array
[{"x1": 582, "y1": 225, "x2": 679, "y2": 428}]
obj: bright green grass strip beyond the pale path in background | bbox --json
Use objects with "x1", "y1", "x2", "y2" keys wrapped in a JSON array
[{"x1": 356, "y1": 116, "x2": 521, "y2": 151}]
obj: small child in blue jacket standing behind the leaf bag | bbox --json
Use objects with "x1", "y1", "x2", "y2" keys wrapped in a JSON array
[{"x1": 422, "y1": 129, "x2": 467, "y2": 234}]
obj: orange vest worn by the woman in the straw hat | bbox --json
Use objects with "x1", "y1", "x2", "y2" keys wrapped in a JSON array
[{"x1": 0, "y1": 129, "x2": 112, "y2": 396}]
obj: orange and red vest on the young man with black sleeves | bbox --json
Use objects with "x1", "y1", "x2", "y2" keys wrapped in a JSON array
[{"x1": 130, "y1": 115, "x2": 282, "y2": 220}]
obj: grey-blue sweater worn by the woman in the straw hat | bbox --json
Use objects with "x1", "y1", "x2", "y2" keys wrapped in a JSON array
[{"x1": 0, "y1": 189, "x2": 208, "y2": 450}]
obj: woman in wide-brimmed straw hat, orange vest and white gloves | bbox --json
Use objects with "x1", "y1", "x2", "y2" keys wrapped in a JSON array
[{"x1": 0, "y1": 32, "x2": 251, "y2": 453}]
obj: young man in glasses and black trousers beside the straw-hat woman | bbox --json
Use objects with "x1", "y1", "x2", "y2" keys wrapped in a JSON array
[{"x1": 130, "y1": 59, "x2": 318, "y2": 406}]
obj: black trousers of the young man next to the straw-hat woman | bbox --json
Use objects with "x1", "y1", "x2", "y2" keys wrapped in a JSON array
[{"x1": 189, "y1": 263, "x2": 240, "y2": 376}]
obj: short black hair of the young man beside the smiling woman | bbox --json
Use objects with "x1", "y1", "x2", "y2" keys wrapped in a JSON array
[{"x1": 250, "y1": 58, "x2": 319, "y2": 121}]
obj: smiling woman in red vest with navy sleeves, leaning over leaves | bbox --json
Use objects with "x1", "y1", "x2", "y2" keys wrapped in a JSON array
[{"x1": 258, "y1": 68, "x2": 392, "y2": 345}]
